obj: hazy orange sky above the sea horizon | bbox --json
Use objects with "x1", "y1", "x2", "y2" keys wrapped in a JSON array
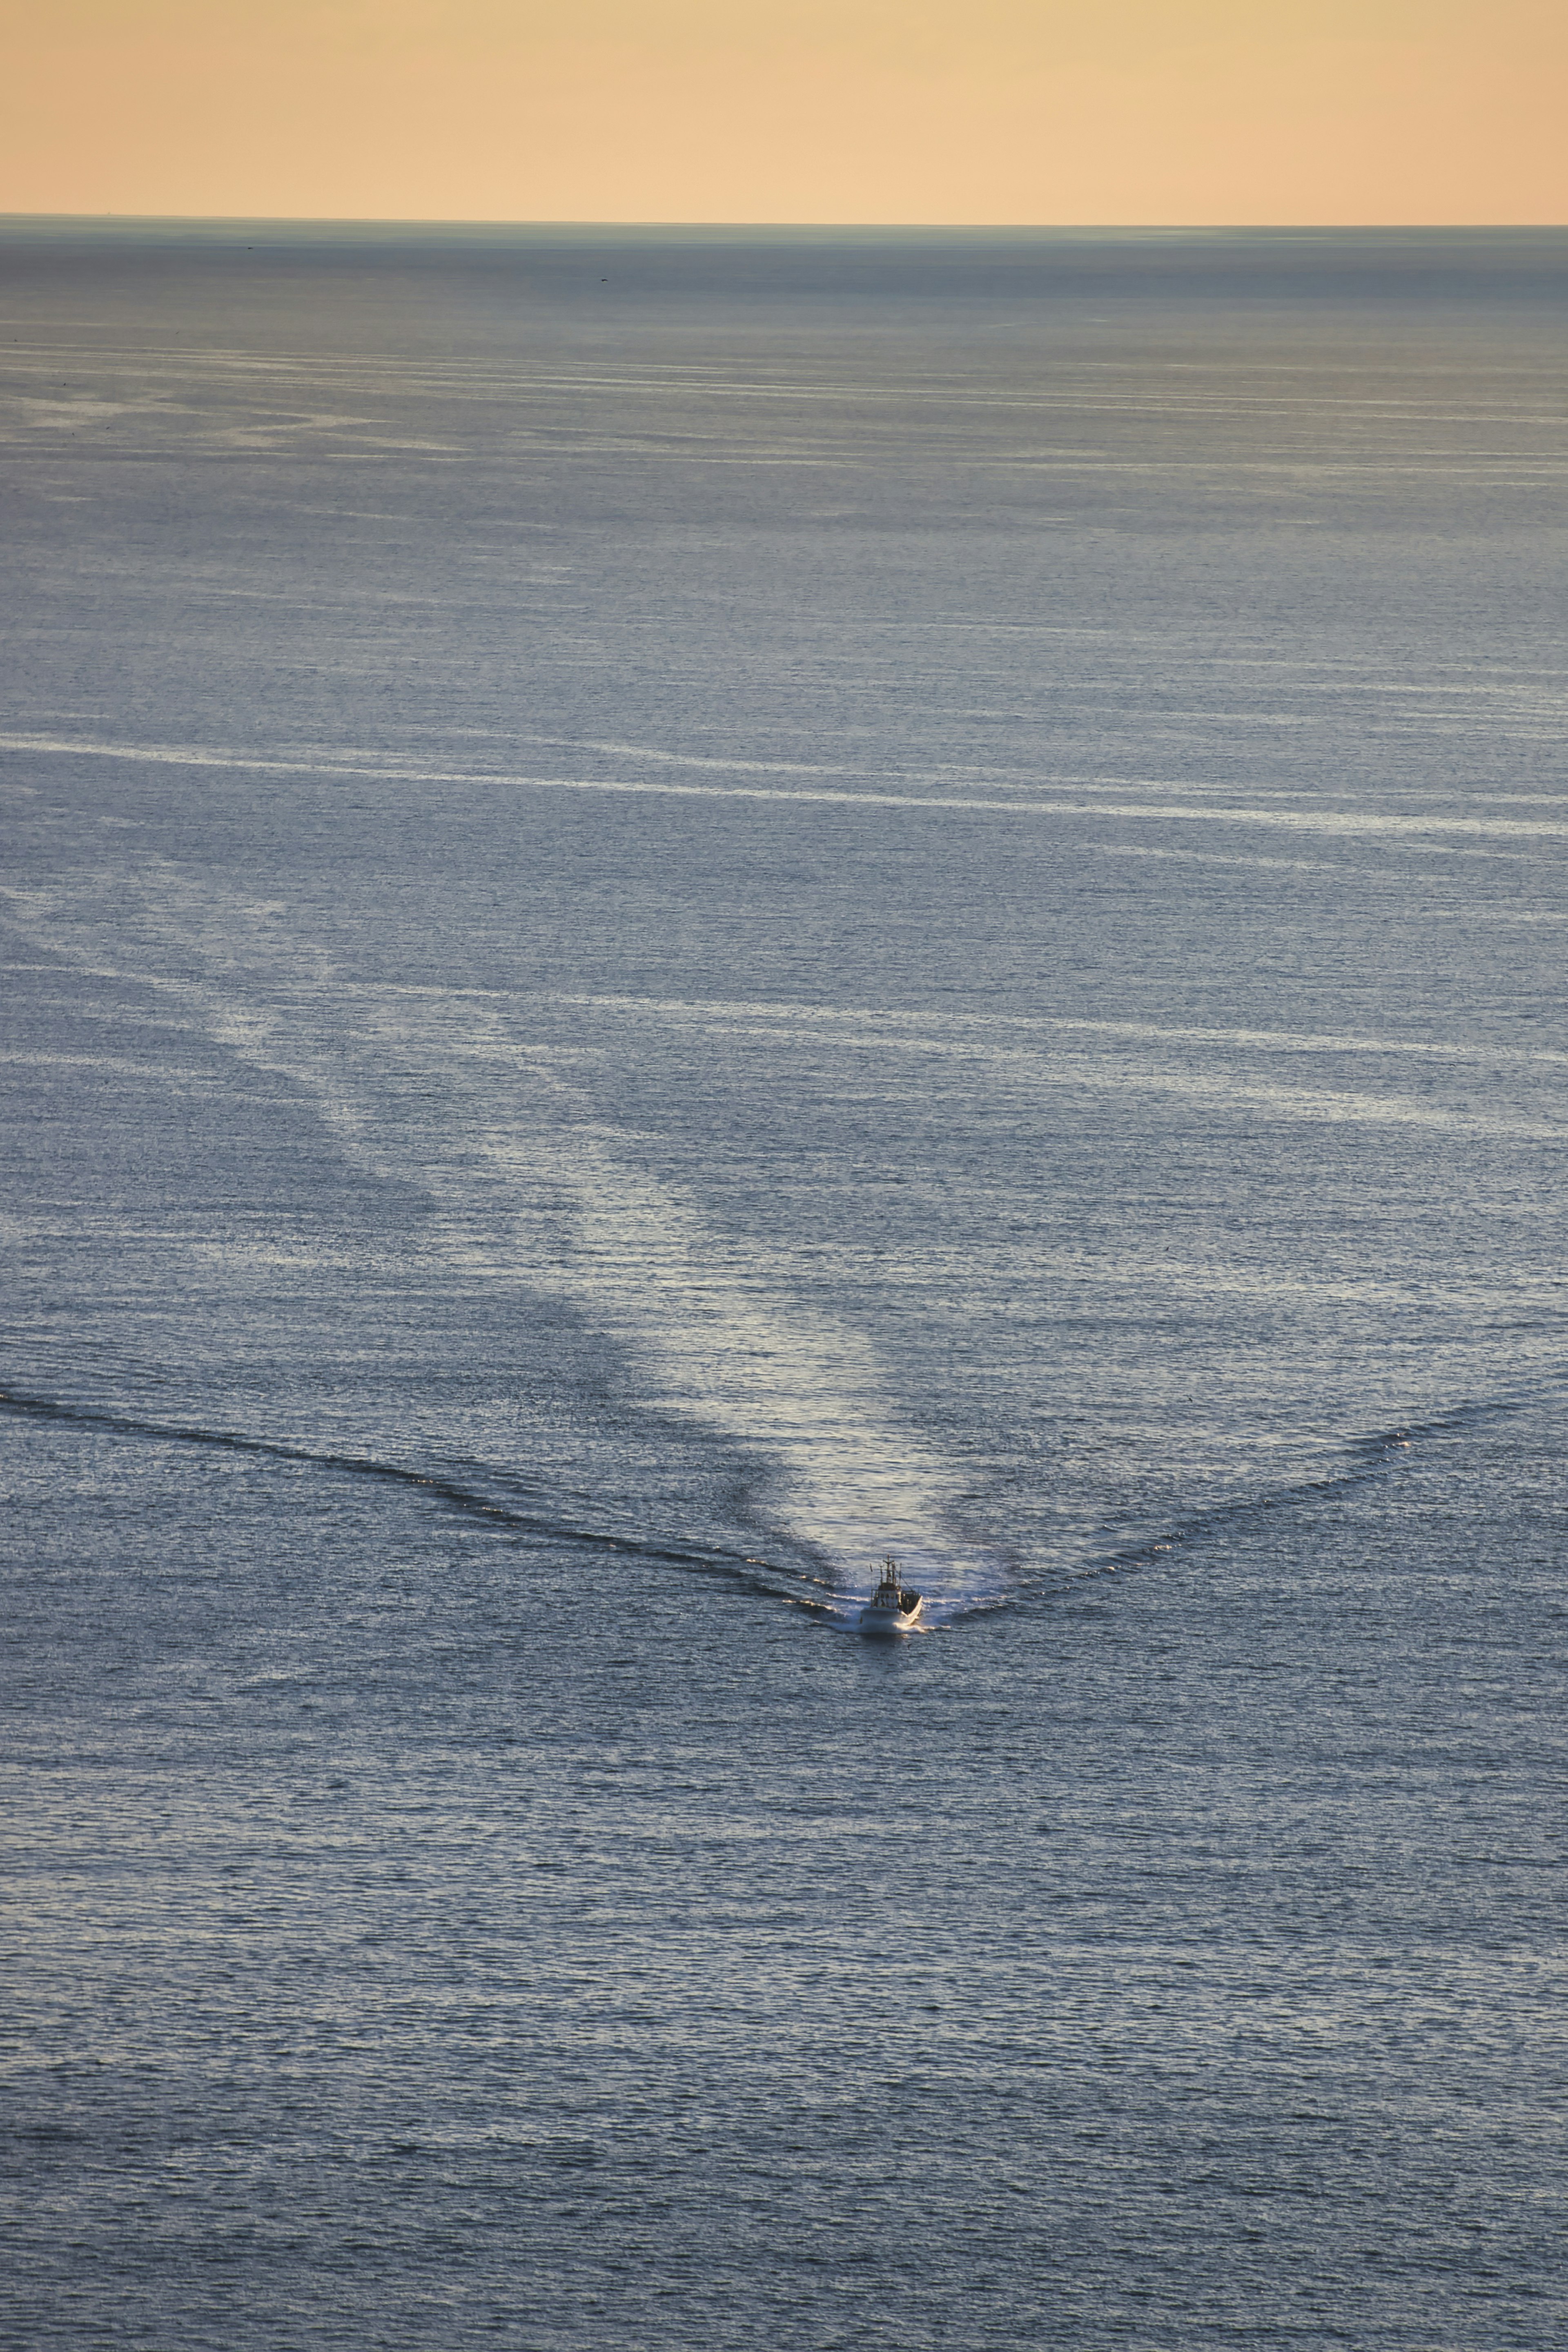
[{"x1": 0, "y1": 0, "x2": 1568, "y2": 223}]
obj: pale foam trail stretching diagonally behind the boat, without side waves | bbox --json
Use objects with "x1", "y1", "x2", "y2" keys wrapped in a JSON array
[{"x1": 6, "y1": 870, "x2": 1006, "y2": 1616}]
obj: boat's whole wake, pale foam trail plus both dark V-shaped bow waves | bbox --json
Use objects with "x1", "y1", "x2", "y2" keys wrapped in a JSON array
[{"x1": 27, "y1": 868, "x2": 1512, "y2": 1630}]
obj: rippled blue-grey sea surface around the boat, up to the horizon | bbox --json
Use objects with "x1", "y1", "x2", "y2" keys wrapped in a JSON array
[{"x1": 0, "y1": 234, "x2": 1568, "y2": 2352}]
